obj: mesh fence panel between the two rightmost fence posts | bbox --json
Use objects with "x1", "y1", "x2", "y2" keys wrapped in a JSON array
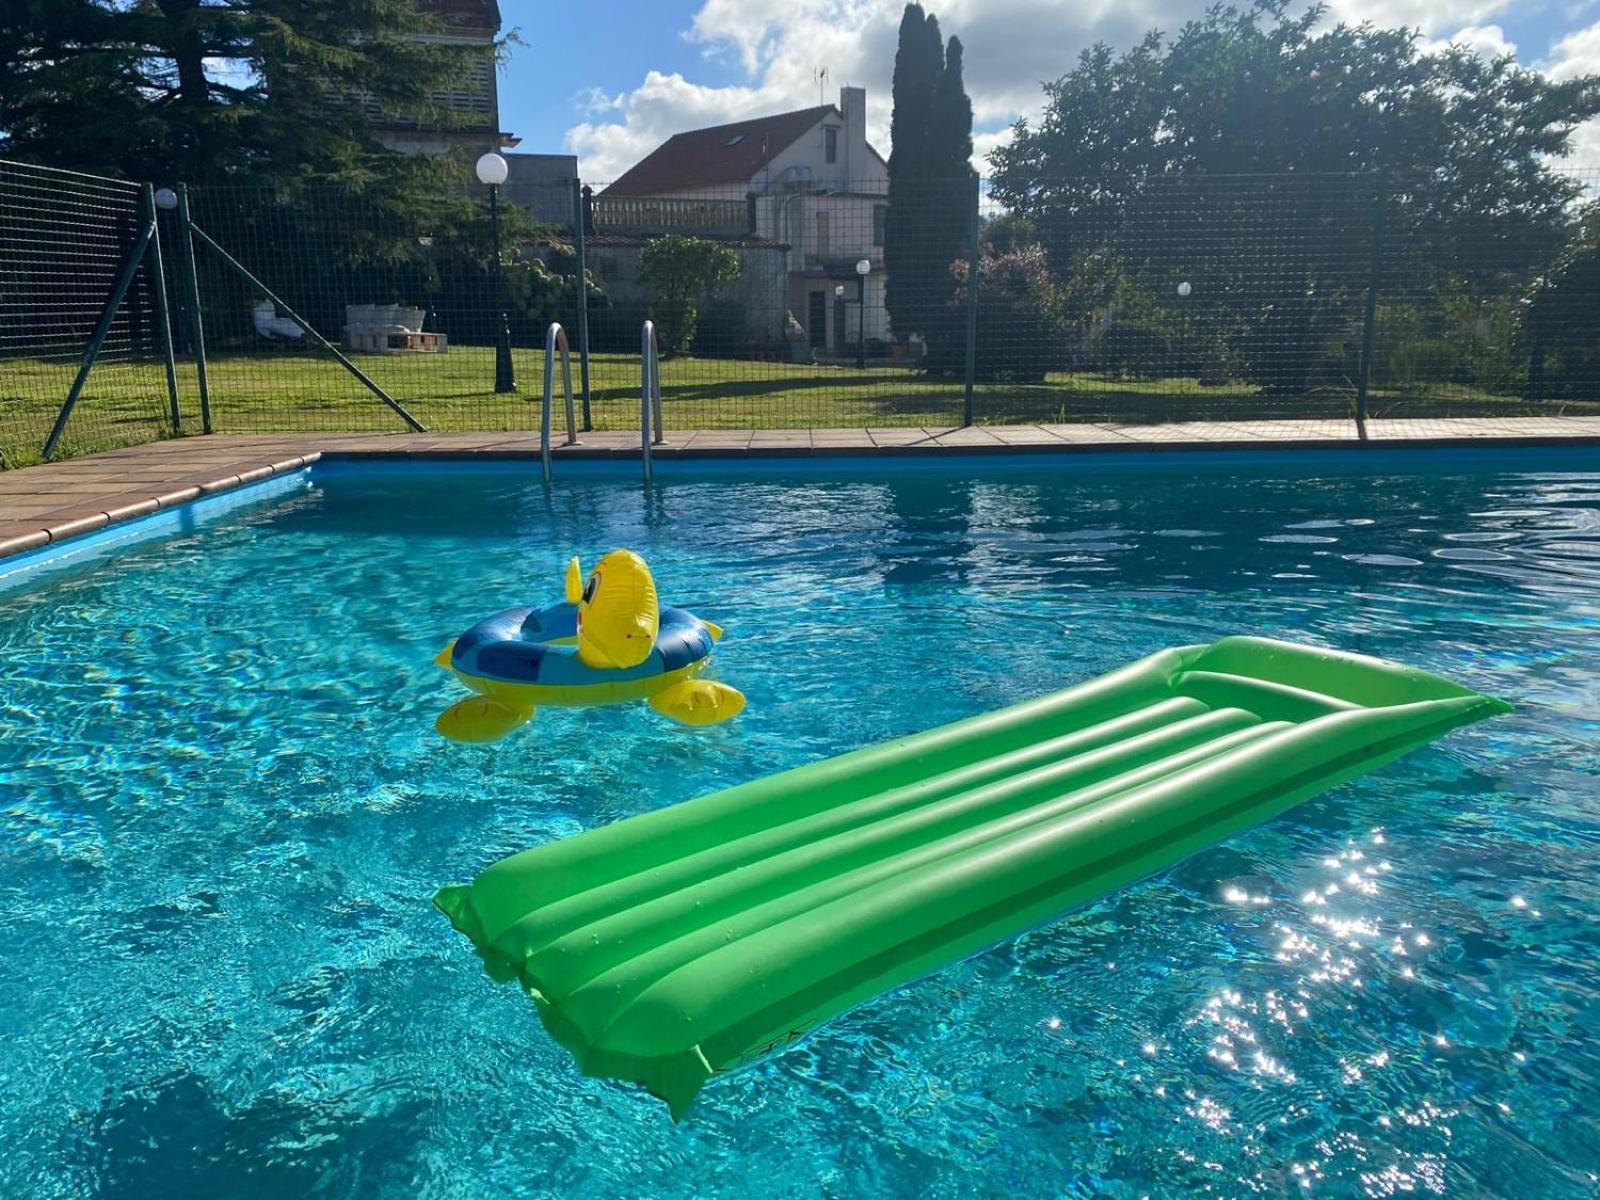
[{"x1": 978, "y1": 176, "x2": 1378, "y2": 422}]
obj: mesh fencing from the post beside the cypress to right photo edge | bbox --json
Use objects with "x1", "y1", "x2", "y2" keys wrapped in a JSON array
[{"x1": 978, "y1": 167, "x2": 1600, "y2": 435}]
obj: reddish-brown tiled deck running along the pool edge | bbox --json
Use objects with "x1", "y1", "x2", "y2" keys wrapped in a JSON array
[{"x1": 0, "y1": 416, "x2": 1600, "y2": 557}]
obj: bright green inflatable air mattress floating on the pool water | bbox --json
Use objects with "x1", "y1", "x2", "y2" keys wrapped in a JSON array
[{"x1": 435, "y1": 637, "x2": 1509, "y2": 1117}]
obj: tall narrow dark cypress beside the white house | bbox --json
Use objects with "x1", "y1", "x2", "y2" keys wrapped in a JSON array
[{"x1": 883, "y1": 3, "x2": 973, "y2": 362}]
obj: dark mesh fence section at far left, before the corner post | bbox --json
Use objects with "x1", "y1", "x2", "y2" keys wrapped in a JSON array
[{"x1": 0, "y1": 162, "x2": 171, "y2": 466}]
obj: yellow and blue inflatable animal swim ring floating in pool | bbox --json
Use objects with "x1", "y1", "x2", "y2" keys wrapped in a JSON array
[{"x1": 434, "y1": 550, "x2": 744, "y2": 742}]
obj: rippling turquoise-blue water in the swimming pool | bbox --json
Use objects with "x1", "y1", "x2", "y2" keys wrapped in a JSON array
[{"x1": 0, "y1": 451, "x2": 1600, "y2": 1200}]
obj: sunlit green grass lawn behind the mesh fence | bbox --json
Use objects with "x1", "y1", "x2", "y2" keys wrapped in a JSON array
[{"x1": 0, "y1": 346, "x2": 1600, "y2": 466}]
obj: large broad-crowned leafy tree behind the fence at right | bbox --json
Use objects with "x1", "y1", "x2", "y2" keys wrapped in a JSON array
[{"x1": 990, "y1": 0, "x2": 1600, "y2": 400}]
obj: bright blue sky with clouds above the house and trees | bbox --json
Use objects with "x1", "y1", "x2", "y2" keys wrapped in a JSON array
[{"x1": 501, "y1": 0, "x2": 1600, "y2": 181}]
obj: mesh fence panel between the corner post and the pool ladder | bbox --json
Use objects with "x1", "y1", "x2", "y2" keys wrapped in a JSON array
[{"x1": 190, "y1": 182, "x2": 588, "y2": 432}]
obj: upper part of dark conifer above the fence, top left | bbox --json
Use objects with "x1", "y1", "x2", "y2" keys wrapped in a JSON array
[{"x1": 0, "y1": 0, "x2": 478, "y2": 187}]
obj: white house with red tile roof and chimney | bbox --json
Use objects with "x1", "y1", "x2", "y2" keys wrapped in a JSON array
[{"x1": 592, "y1": 88, "x2": 891, "y2": 355}]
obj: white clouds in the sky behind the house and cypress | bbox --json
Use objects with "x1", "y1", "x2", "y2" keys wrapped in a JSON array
[{"x1": 566, "y1": 0, "x2": 1600, "y2": 181}]
